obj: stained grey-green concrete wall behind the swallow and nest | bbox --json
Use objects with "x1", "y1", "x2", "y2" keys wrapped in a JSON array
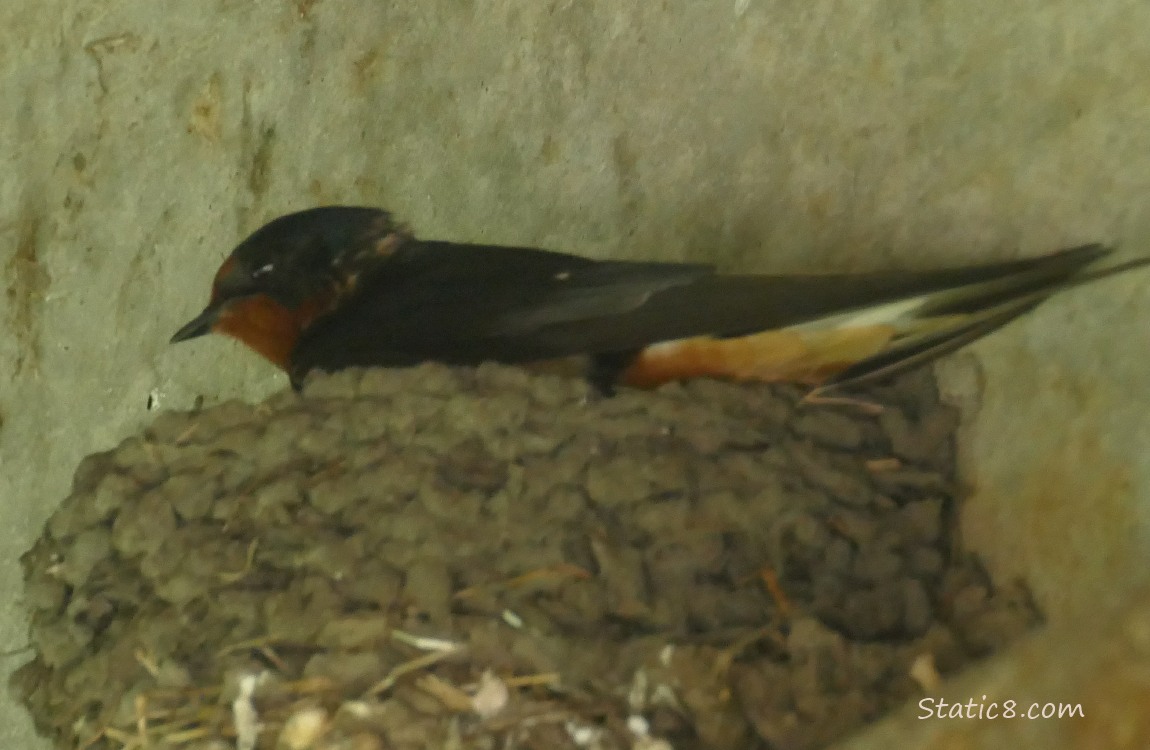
[{"x1": 0, "y1": 0, "x2": 1150, "y2": 748}]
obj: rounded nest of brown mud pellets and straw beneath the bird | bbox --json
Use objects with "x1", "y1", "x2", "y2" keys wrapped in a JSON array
[{"x1": 13, "y1": 366, "x2": 1035, "y2": 750}]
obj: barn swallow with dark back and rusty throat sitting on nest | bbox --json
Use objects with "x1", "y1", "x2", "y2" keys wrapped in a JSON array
[{"x1": 171, "y1": 206, "x2": 1150, "y2": 392}]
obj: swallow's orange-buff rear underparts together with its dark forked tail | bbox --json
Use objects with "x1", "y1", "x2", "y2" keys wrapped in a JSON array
[{"x1": 623, "y1": 245, "x2": 1150, "y2": 393}]
